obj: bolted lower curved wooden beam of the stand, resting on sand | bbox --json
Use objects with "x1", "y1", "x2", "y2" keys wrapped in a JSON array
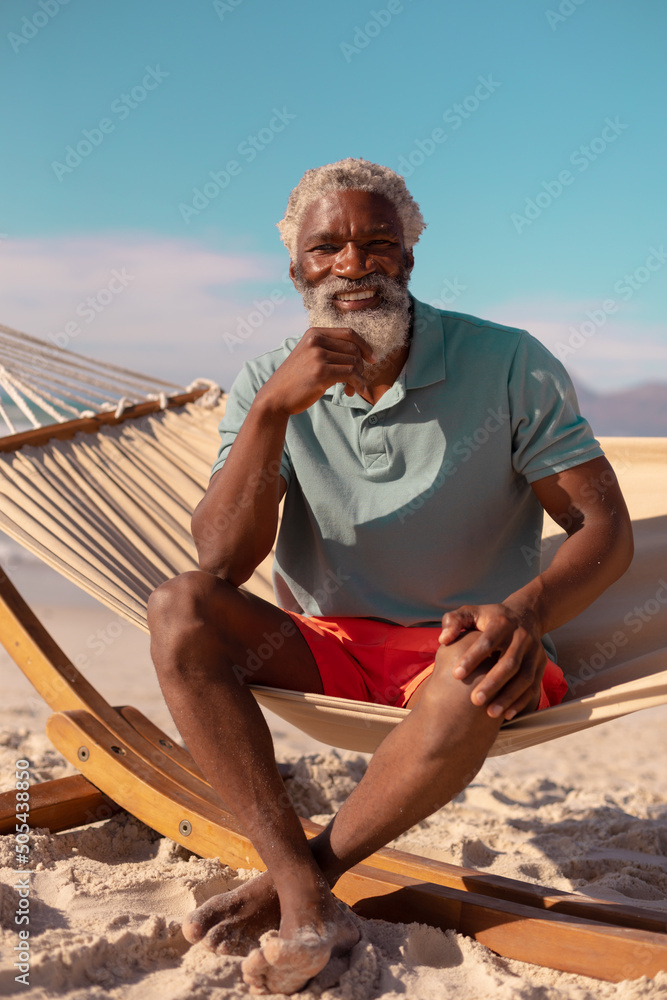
[{"x1": 40, "y1": 711, "x2": 667, "y2": 982}]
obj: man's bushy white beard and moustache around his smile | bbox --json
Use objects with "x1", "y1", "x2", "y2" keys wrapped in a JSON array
[{"x1": 296, "y1": 274, "x2": 410, "y2": 375}]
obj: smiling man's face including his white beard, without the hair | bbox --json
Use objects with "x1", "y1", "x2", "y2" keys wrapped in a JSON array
[{"x1": 290, "y1": 191, "x2": 414, "y2": 368}]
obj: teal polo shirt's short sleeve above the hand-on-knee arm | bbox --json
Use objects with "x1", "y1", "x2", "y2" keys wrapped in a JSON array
[{"x1": 508, "y1": 333, "x2": 604, "y2": 483}]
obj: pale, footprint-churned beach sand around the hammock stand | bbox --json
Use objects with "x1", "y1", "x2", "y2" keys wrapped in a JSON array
[{"x1": 0, "y1": 542, "x2": 667, "y2": 1000}]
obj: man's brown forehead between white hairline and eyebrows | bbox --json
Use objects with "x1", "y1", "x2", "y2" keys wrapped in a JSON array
[{"x1": 299, "y1": 191, "x2": 403, "y2": 247}]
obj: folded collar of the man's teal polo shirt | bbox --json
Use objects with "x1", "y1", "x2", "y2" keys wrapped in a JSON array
[{"x1": 323, "y1": 295, "x2": 445, "y2": 409}]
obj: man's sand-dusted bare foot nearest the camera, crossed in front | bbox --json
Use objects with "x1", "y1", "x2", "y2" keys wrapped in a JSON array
[{"x1": 241, "y1": 896, "x2": 360, "y2": 994}]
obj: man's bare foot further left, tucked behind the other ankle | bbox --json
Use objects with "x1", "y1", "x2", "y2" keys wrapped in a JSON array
[{"x1": 181, "y1": 872, "x2": 280, "y2": 955}]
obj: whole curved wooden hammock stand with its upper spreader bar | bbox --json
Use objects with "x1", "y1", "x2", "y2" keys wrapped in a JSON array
[{"x1": 0, "y1": 390, "x2": 667, "y2": 982}]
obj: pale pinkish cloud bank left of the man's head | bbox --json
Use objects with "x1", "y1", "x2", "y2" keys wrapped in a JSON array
[{"x1": 0, "y1": 233, "x2": 305, "y2": 387}]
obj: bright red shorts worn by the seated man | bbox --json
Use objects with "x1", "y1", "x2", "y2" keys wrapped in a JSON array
[{"x1": 283, "y1": 609, "x2": 567, "y2": 709}]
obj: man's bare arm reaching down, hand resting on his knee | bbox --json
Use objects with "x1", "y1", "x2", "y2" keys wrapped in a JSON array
[{"x1": 440, "y1": 458, "x2": 633, "y2": 718}]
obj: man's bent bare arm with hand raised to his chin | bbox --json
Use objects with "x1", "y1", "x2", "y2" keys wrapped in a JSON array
[{"x1": 192, "y1": 328, "x2": 374, "y2": 587}]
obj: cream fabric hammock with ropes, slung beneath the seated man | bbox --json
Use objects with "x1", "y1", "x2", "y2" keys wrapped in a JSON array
[{"x1": 0, "y1": 327, "x2": 667, "y2": 755}]
